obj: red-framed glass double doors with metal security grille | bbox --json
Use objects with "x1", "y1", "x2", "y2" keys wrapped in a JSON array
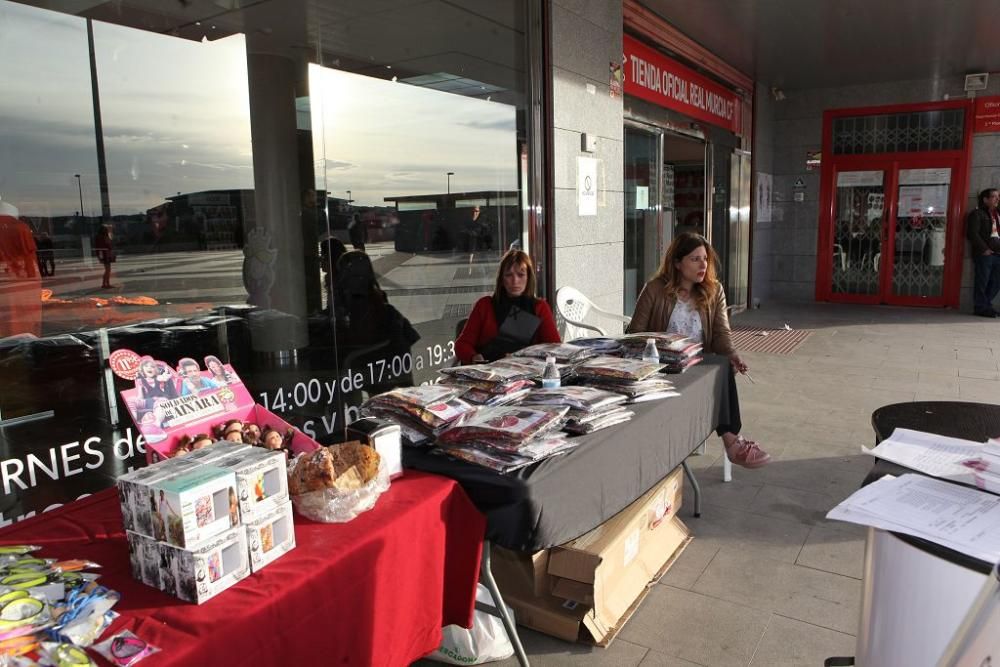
[{"x1": 816, "y1": 102, "x2": 969, "y2": 306}]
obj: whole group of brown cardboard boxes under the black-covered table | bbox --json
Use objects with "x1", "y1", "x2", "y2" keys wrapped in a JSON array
[{"x1": 495, "y1": 468, "x2": 690, "y2": 646}]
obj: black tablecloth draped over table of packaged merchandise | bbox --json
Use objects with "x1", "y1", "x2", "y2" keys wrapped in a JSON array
[{"x1": 403, "y1": 355, "x2": 729, "y2": 551}]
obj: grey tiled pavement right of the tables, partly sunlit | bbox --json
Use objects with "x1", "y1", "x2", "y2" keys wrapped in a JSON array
[{"x1": 422, "y1": 304, "x2": 1000, "y2": 667}]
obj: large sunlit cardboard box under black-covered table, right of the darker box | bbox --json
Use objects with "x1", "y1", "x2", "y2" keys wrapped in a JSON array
[{"x1": 548, "y1": 468, "x2": 688, "y2": 639}]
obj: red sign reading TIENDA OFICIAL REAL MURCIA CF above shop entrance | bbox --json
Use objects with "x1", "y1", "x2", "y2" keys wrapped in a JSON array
[{"x1": 624, "y1": 35, "x2": 742, "y2": 134}]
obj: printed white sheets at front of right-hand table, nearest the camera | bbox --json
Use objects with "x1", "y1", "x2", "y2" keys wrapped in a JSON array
[{"x1": 826, "y1": 474, "x2": 1000, "y2": 563}]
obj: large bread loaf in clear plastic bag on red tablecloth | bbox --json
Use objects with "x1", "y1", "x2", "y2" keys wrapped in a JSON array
[{"x1": 288, "y1": 442, "x2": 389, "y2": 523}]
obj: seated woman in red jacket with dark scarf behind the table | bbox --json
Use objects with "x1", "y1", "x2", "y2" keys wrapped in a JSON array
[{"x1": 455, "y1": 250, "x2": 561, "y2": 364}]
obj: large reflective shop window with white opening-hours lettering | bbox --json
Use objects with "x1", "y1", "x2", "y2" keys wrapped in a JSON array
[{"x1": 0, "y1": 0, "x2": 535, "y2": 521}]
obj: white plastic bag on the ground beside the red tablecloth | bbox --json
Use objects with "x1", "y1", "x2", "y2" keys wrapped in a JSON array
[{"x1": 426, "y1": 584, "x2": 514, "y2": 665}]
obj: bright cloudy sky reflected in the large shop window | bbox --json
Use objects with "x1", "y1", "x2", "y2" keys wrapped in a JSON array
[{"x1": 0, "y1": 2, "x2": 518, "y2": 216}]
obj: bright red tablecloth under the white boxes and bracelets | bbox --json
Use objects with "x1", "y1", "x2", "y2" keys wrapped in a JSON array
[{"x1": 0, "y1": 471, "x2": 485, "y2": 667}]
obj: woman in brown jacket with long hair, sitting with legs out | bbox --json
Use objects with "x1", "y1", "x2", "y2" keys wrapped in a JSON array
[{"x1": 628, "y1": 233, "x2": 771, "y2": 468}]
